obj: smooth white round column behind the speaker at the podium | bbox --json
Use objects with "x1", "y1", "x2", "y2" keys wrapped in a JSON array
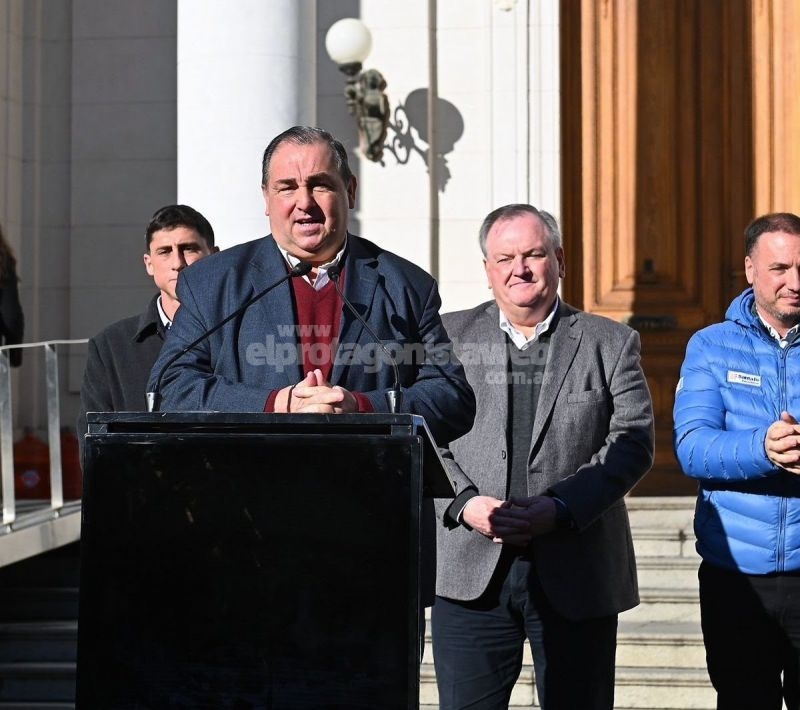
[{"x1": 178, "y1": 0, "x2": 317, "y2": 248}]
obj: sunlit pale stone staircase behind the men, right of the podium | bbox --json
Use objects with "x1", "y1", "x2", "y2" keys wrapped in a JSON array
[{"x1": 420, "y1": 497, "x2": 715, "y2": 710}]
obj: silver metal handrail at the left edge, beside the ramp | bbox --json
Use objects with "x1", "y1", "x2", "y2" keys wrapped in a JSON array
[{"x1": 0, "y1": 338, "x2": 89, "y2": 532}]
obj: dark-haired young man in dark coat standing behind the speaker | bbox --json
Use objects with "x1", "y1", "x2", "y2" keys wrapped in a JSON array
[{"x1": 78, "y1": 205, "x2": 219, "y2": 437}]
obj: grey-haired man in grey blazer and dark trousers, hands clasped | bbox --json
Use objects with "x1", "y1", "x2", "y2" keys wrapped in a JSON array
[{"x1": 432, "y1": 205, "x2": 653, "y2": 710}]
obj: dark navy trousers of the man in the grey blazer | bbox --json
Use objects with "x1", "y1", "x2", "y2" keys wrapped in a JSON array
[{"x1": 431, "y1": 557, "x2": 617, "y2": 710}]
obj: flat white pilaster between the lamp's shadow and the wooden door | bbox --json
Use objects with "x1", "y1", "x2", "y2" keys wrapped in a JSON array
[{"x1": 434, "y1": 0, "x2": 561, "y2": 311}]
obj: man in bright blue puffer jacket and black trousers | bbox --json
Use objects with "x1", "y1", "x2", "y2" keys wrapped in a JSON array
[{"x1": 675, "y1": 213, "x2": 800, "y2": 710}]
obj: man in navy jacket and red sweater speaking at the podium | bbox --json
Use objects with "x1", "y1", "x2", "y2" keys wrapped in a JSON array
[{"x1": 149, "y1": 126, "x2": 475, "y2": 450}]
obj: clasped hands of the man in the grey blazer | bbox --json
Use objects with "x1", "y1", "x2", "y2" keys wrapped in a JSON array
[{"x1": 461, "y1": 496, "x2": 556, "y2": 547}]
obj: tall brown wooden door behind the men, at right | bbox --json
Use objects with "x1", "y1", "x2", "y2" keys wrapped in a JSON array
[{"x1": 560, "y1": 0, "x2": 800, "y2": 495}]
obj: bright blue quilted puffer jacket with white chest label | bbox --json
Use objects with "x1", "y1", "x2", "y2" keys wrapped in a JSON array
[{"x1": 674, "y1": 289, "x2": 800, "y2": 574}]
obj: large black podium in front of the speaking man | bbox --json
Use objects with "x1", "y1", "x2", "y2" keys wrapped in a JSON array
[{"x1": 77, "y1": 413, "x2": 452, "y2": 710}]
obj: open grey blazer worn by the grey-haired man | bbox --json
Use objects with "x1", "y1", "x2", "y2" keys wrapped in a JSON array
[{"x1": 436, "y1": 301, "x2": 653, "y2": 620}]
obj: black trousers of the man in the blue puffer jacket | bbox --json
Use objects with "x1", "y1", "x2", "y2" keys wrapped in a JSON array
[{"x1": 698, "y1": 562, "x2": 800, "y2": 710}]
